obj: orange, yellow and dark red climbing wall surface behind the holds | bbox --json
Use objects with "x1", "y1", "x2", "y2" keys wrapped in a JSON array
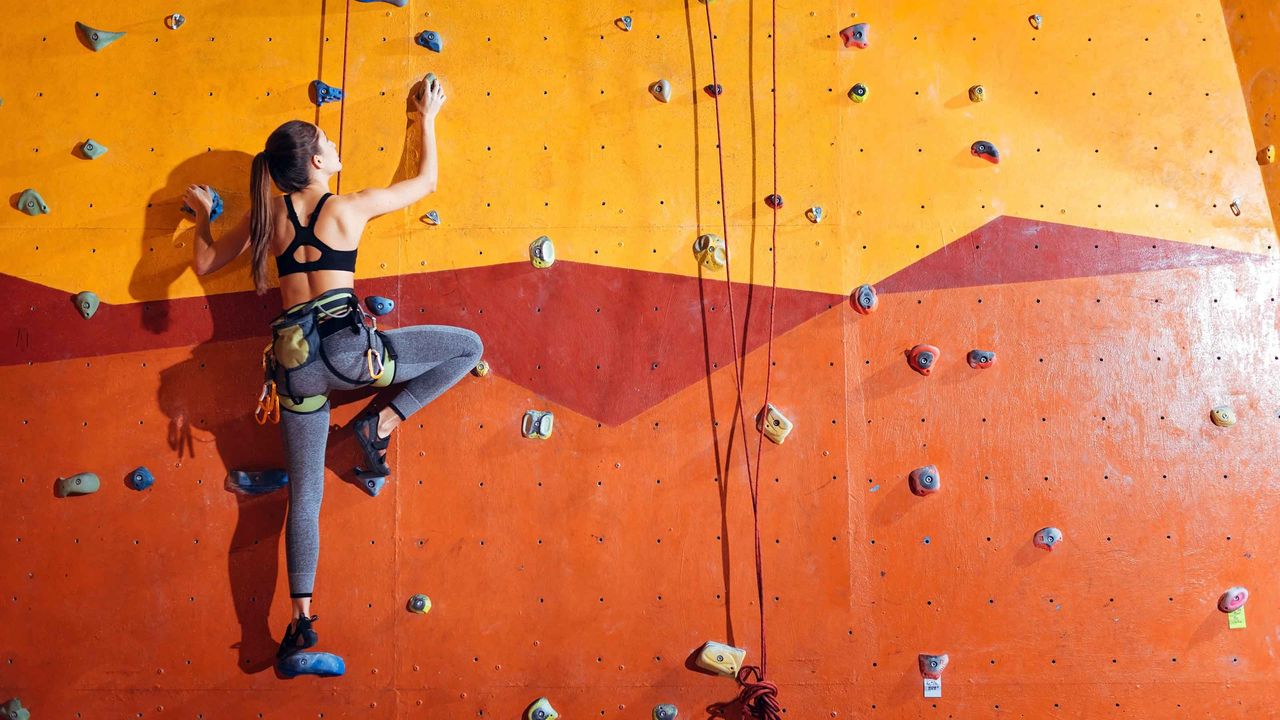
[{"x1": 0, "y1": 0, "x2": 1280, "y2": 720}]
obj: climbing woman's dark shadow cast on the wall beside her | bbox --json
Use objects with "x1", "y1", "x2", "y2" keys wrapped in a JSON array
[{"x1": 129, "y1": 131, "x2": 419, "y2": 673}]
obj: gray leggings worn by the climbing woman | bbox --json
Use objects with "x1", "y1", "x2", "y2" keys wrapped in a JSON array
[{"x1": 280, "y1": 319, "x2": 484, "y2": 597}]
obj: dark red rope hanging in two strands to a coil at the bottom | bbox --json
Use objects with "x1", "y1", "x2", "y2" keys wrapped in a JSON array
[{"x1": 704, "y1": 0, "x2": 781, "y2": 720}]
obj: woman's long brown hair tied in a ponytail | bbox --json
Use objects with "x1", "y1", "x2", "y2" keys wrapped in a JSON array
[{"x1": 248, "y1": 120, "x2": 320, "y2": 295}]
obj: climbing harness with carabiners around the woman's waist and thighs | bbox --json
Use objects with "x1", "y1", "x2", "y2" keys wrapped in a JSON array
[{"x1": 253, "y1": 288, "x2": 396, "y2": 425}]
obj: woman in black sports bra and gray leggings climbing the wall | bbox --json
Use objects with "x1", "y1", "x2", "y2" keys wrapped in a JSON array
[{"x1": 186, "y1": 76, "x2": 484, "y2": 659}]
